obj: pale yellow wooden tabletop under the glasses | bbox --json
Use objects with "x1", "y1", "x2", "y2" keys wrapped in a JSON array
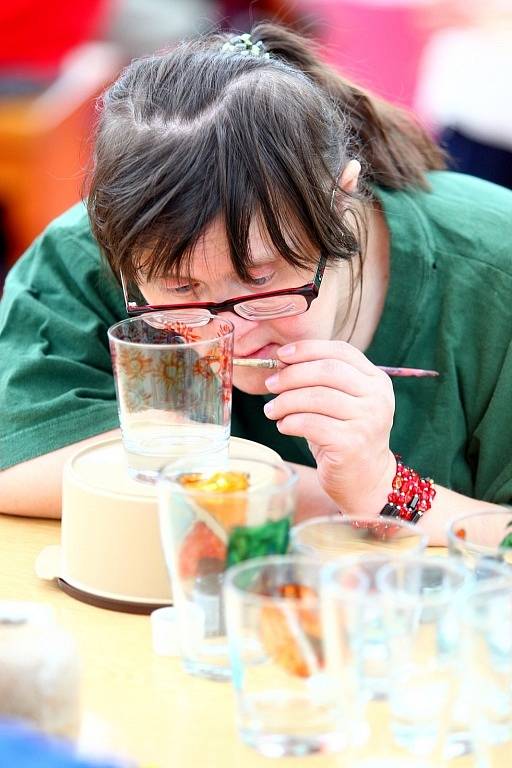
[{"x1": 0, "y1": 515, "x2": 476, "y2": 768}]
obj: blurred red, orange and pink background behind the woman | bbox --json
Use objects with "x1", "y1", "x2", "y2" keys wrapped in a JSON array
[{"x1": 0, "y1": 0, "x2": 512, "y2": 290}]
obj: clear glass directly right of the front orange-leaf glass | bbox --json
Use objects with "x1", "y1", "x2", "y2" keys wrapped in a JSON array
[{"x1": 376, "y1": 555, "x2": 471, "y2": 765}]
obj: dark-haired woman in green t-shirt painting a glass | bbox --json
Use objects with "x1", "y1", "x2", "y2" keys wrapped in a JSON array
[{"x1": 0, "y1": 24, "x2": 512, "y2": 543}]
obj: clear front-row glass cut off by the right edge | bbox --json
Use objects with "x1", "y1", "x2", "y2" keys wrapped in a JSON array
[{"x1": 459, "y1": 579, "x2": 512, "y2": 768}]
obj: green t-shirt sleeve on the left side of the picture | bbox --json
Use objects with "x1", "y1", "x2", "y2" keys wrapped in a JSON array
[{"x1": 0, "y1": 212, "x2": 122, "y2": 469}]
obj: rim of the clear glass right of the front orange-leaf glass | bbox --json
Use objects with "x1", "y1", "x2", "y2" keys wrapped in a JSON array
[{"x1": 375, "y1": 554, "x2": 472, "y2": 605}]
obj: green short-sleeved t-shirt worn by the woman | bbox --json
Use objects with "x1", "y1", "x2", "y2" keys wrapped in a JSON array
[{"x1": 0, "y1": 172, "x2": 512, "y2": 503}]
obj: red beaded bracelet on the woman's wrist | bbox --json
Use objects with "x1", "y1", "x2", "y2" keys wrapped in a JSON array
[{"x1": 380, "y1": 456, "x2": 436, "y2": 523}]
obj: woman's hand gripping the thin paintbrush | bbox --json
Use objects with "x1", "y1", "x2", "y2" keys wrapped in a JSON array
[{"x1": 265, "y1": 340, "x2": 396, "y2": 517}]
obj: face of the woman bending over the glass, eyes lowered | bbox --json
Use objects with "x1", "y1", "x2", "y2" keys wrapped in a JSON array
[{"x1": 139, "y1": 222, "x2": 347, "y2": 394}]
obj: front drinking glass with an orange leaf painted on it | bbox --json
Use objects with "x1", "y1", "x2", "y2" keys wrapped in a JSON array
[{"x1": 224, "y1": 555, "x2": 365, "y2": 757}]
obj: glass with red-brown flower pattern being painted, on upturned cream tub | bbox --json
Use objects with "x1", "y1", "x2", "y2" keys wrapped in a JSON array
[{"x1": 108, "y1": 312, "x2": 233, "y2": 481}]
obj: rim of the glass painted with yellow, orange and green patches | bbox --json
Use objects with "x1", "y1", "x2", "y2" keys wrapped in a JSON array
[{"x1": 156, "y1": 456, "x2": 299, "y2": 499}]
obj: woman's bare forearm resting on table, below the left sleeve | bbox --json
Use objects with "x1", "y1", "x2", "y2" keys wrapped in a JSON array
[{"x1": 0, "y1": 429, "x2": 120, "y2": 518}]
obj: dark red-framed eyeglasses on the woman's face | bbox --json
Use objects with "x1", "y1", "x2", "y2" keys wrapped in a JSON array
[{"x1": 121, "y1": 256, "x2": 327, "y2": 322}]
